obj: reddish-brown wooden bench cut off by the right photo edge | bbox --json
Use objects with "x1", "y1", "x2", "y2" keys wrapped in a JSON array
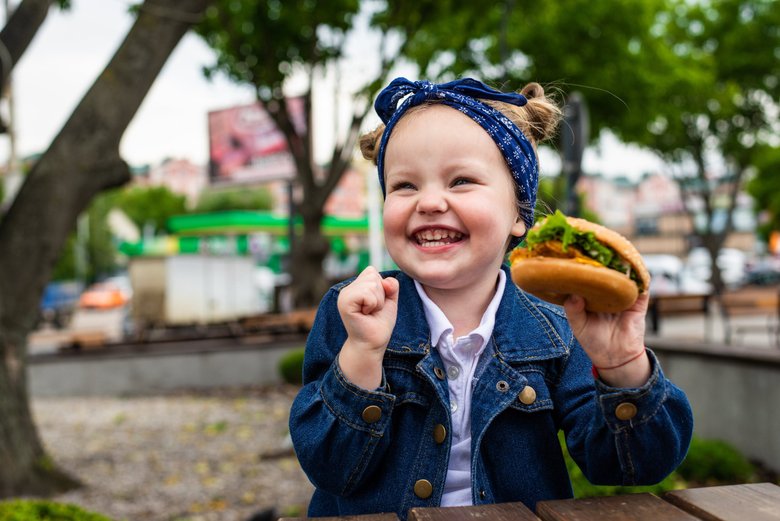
[{"x1": 718, "y1": 288, "x2": 780, "y2": 347}]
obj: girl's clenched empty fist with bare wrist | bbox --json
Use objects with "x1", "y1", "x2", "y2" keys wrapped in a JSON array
[{"x1": 338, "y1": 266, "x2": 398, "y2": 389}]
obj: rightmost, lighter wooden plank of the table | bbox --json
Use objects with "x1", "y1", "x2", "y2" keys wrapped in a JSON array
[{"x1": 664, "y1": 483, "x2": 780, "y2": 521}]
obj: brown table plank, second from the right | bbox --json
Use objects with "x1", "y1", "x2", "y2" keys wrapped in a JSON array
[{"x1": 536, "y1": 494, "x2": 700, "y2": 521}]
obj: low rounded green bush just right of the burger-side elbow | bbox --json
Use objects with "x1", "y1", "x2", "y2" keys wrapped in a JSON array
[{"x1": 677, "y1": 438, "x2": 756, "y2": 485}]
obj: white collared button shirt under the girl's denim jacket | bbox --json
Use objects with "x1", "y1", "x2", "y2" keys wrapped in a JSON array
[{"x1": 414, "y1": 270, "x2": 506, "y2": 506}]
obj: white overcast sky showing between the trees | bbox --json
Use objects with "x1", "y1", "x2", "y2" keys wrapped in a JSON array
[{"x1": 0, "y1": 0, "x2": 659, "y2": 176}]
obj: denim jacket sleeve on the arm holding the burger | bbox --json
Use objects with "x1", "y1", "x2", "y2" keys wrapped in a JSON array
[{"x1": 557, "y1": 340, "x2": 693, "y2": 485}]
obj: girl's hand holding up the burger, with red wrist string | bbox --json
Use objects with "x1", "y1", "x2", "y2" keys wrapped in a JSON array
[{"x1": 564, "y1": 293, "x2": 650, "y2": 387}]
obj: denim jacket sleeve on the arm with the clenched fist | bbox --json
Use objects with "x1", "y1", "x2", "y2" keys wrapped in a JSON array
[{"x1": 290, "y1": 287, "x2": 395, "y2": 496}]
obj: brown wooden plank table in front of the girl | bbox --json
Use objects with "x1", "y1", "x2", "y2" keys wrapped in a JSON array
[{"x1": 281, "y1": 483, "x2": 780, "y2": 521}]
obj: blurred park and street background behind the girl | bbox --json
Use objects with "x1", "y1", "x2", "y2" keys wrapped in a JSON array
[{"x1": 0, "y1": 0, "x2": 780, "y2": 519}]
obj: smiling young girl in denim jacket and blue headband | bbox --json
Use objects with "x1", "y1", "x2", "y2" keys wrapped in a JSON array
[{"x1": 290, "y1": 78, "x2": 692, "y2": 519}]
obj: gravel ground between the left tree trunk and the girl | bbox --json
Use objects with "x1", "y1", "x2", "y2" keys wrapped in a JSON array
[{"x1": 32, "y1": 386, "x2": 313, "y2": 521}]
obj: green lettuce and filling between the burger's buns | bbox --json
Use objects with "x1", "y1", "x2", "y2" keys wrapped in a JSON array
[{"x1": 510, "y1": 210, "x2": 642, "y2": 288}]
